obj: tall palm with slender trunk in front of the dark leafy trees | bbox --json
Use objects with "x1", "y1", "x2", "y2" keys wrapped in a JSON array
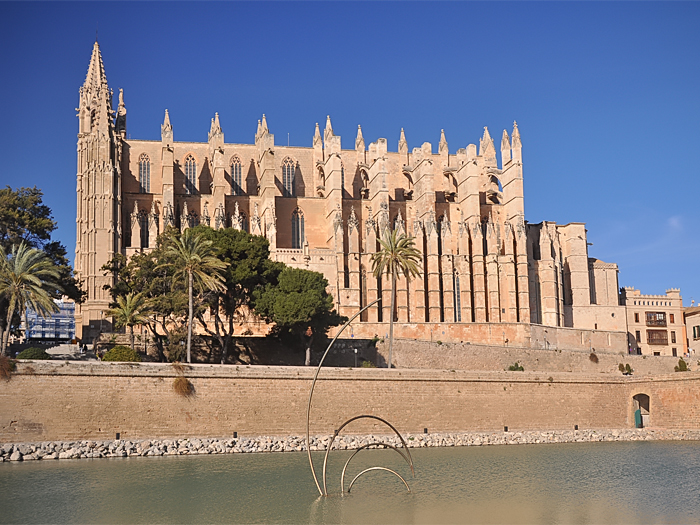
[{"x1": 160, "y1": 228, "x2": 226, "y2": 363}]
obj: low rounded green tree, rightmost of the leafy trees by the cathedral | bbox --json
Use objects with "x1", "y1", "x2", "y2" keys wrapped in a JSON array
[{"x1": 253, "y1": 267, "x2": 347, "y2": 366}]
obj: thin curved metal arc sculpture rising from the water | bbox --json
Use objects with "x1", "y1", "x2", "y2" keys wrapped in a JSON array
[{"x1": 306, "y1": 299, "x2": 416, "y2": 496}]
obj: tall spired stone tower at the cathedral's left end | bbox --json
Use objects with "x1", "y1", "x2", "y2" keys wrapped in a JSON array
[{"x1": 75, "y1": 42, "x2": 126, "y2": 342}]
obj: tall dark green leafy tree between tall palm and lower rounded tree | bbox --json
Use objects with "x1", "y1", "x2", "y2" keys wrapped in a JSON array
[{"x1": 194, "y1": 226, "x2": 284, "y2": 364}]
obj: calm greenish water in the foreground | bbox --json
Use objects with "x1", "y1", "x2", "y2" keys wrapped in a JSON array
[{"x1": 0, "y1": 442, "x2": 700, "y2": 524}]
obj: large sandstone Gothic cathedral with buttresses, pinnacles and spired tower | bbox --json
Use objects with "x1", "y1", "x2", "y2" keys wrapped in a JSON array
[{"x1": 75, "y1": 43, "x2": 626, "y2": 349}]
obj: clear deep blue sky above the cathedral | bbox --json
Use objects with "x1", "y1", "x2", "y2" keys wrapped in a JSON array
[{"x1": 0, "y1": 2, "x2": 700, "y2": 304}]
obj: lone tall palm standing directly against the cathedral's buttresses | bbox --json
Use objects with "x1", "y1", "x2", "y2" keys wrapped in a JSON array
[{"x1": 372, "y1": 230, "x2": 421, "y2": 368}]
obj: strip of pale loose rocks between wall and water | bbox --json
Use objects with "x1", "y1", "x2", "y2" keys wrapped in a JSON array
[{"x1": 0, "y1": 429, "x2": 700, "y2": 461}]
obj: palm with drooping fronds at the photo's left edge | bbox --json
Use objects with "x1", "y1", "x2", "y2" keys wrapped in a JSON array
[{"x1": 0, "y1": 242, "x2": 61, "y2": 355}]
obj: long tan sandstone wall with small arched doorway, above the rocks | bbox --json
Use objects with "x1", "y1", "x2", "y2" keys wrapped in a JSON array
[{"x1": 0, "y1": 362, "x2": 700, "y2": 442}]
